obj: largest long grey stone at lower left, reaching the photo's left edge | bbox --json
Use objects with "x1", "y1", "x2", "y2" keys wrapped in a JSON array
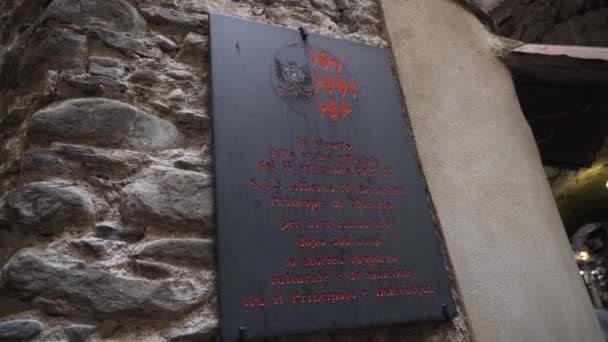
[{"x1": 2, "y1": 249, "x2": 209, "y2": 320}]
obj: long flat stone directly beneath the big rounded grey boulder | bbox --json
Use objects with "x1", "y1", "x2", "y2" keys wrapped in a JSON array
[{"x1": 22, "y1": 144, "x2": 150, "y2": 179}]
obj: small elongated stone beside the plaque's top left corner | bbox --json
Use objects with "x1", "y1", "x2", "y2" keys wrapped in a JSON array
[{"x1": 140, "y1": 6, "x2": 209, "y2": 34}]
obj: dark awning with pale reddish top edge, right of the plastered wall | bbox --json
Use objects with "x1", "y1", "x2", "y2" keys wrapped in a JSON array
[{"x1": 506, "y1": 44, "x2": 608, "y2": 169}]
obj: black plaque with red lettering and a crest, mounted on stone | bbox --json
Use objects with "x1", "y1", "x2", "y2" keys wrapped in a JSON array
[{"x1": 210, "y1": 14, "x2": 456, "y2": 341}]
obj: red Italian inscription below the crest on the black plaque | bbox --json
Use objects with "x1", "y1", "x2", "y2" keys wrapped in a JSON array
[{"x1": 243, "y1": 137, "x2": 435, "y2": 307}]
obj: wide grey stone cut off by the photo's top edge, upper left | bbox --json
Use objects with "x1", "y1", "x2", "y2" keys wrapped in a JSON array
[{"x1": 42, "y1": 0, "x2": 146, "y2": 36}]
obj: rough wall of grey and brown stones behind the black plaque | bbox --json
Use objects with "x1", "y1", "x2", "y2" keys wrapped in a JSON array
[{"x1": 0, "y1": 0, "x2": 470, "y2": 341}]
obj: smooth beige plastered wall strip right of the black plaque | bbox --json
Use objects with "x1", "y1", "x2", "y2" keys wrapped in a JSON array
[{"x1": 380, "y1": 0, "x2": 603, "y2": 342}]
